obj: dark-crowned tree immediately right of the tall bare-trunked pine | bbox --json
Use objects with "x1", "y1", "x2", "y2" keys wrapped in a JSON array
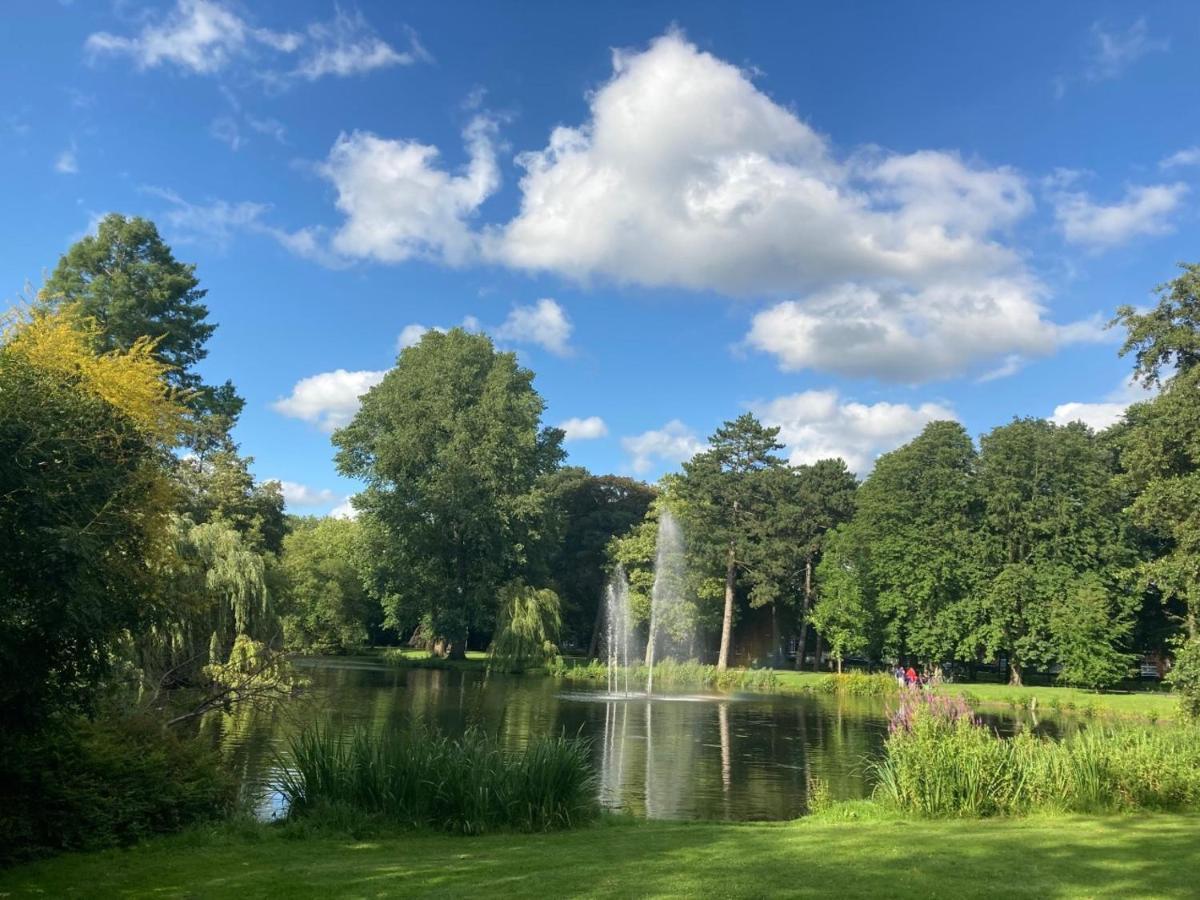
[{"x1": 751, "y1": 460, "x2": 858, "y2": 668}]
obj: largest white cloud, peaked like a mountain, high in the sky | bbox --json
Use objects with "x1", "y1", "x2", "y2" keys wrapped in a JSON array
[{"x1": 488, "y1": 32, "x2": 1031, "y2": 294}]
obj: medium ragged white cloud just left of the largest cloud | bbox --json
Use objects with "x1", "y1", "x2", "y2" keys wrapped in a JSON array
[{"x1": 322, "y1": 116, "x2": 500, "y2": 265}]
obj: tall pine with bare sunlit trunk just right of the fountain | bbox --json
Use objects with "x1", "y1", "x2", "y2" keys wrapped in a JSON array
[{"x1": 679, "y1": 413, "x2": 784, "y2": 671}]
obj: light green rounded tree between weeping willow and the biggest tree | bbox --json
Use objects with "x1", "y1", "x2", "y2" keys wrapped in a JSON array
[{"x1": 277, "y1": 517, "x2": 382, "y2": 653}]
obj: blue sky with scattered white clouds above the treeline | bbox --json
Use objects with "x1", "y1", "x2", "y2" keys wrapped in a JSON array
[{"x1": 0, "y1": 0, "x2": 1200, "y2": 514}]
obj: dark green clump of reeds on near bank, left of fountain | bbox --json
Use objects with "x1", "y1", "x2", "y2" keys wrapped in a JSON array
[{"x1": 277, "y1": 726, "x2": 599, "y2": 834}]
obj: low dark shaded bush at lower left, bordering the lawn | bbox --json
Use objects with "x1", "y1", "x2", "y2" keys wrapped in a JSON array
[{"x1": 0, "y1": 716, "x2": 236, "y2": 863}]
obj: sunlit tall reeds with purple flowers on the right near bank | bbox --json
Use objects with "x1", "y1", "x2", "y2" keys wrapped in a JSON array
[{"x1": 874, "y1": 690, "x2": 1200, "y2": 817}]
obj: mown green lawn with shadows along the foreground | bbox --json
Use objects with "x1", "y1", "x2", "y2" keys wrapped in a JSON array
[{"x1": 0, "y1": 815, "x2": 1200, "y2": 900}]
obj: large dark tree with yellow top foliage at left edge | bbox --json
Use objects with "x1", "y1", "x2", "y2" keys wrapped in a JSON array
[{"x1": 0, "y1": 310, "x2": 182, "y2": 727}]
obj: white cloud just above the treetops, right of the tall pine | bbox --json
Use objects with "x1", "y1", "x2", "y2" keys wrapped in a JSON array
[{"x1": 751, "y1": 390, "x2": 958, "y2": 475}]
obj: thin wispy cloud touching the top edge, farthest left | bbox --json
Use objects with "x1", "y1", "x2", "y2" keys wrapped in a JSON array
[{"x1": 84, "y1": 0, "x2": 301, "y2": 74}]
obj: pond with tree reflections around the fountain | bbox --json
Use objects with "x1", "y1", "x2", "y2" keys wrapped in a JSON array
[{"x1": 200, "y1": 658, "x2": 1060, "y2": 820}]
